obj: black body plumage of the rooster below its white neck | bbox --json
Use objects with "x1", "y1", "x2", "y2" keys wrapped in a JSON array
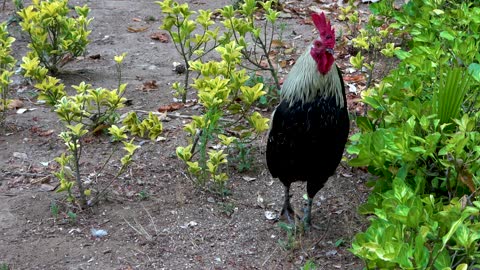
[{"x1": 266, "y1": 66, "x2": 350, "y2": 198}]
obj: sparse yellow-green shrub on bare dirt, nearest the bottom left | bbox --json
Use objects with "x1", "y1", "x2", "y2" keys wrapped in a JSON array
[{"x1": 22, "y1": 54, "x2": 162, "y2": 207}]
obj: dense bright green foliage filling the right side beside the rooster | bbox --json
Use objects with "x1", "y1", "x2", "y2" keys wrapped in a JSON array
[{"x1": 348, "y1": 0, "x2": 480, "y2": 269}]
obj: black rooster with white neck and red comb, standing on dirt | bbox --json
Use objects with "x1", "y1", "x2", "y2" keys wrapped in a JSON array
[{"x1": 266, "y1": 12, "x2": 350, "y2": 228}]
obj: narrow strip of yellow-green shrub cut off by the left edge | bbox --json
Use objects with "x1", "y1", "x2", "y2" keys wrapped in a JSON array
[{"x1": 0, "y1": 23, "x2": 16, "y2": 126}]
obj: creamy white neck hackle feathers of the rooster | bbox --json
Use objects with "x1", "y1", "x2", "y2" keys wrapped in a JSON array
[{"x1": 280, "y1": 47, "x2": 344, "y2": 108}]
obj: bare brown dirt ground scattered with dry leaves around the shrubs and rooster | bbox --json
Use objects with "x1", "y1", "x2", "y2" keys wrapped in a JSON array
[{"x1": 0, "y1": 0, "x2": 374, "y2": 269}]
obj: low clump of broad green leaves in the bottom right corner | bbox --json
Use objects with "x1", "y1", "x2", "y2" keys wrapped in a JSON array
[{"x1": 351, "y1": 178, "x2": 480, "y2": 269}]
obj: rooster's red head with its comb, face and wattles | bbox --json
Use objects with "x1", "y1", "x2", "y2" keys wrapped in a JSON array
[{"x1": 310, "y1": 12, "x2": 335, "y2": 75}]
